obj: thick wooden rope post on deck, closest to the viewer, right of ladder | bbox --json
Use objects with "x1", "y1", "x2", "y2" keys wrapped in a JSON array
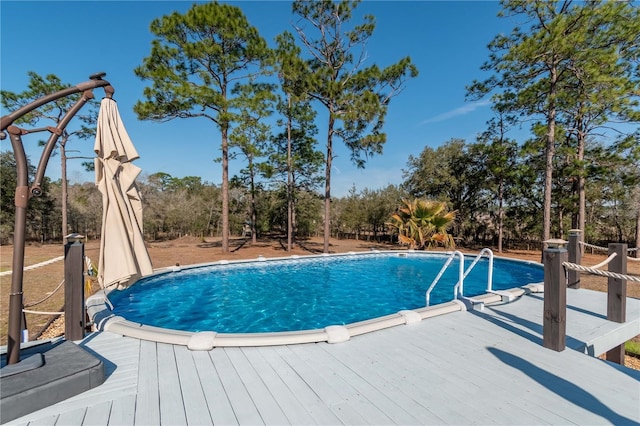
[{"x1": 542, "y1": 240, "x2": 567, "y2": 352}]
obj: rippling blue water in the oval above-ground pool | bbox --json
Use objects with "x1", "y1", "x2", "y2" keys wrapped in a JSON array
[{"x1": 109, "y1": 253, "x2": 543, "y2": 333}]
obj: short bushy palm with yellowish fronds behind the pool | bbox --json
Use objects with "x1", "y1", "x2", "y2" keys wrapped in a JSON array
[{"x1": 389, "y1": 198, "x2": 456, "y2": 250}]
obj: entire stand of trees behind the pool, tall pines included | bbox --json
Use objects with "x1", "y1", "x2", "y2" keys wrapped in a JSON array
[{"x1": 2, "y1": 0, "x2": 640, "y2": 251}]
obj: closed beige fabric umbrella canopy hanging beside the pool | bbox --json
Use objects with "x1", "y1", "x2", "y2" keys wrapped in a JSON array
[{"x1": 93, "y1": 98, "x2": 153, "y2": 288}]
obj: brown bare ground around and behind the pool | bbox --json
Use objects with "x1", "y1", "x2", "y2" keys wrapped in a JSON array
[{"x1": 0, "y1": 237, "x2": 640, "y2": 369}]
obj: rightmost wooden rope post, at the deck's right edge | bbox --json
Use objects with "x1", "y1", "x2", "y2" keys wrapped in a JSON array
[{"x1": 607, "y1": 243, "x2": 627, "y2": 365}]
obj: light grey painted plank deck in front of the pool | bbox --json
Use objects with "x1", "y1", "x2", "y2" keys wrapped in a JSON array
[{"x1": 6, "y1": 290, "x2": 640, "y2": 425}]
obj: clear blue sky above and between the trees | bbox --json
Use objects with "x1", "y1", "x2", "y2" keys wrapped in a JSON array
[{"x1": 0, "y1": 0, "x2": 526, "y2": 196}]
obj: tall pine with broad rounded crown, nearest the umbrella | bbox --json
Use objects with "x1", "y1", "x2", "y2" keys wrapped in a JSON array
[{"x1": 134, "y1": 2, "x2": 269, "y2": 252}]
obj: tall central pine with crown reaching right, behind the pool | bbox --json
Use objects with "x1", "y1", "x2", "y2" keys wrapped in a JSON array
[{"x1": 293, "y1": 0, "x2": 418, "y2": 253}]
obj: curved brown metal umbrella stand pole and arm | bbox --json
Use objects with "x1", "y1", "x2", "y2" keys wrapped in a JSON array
[{"x1": 0, "y1": 73, "x2": 114, "y2": 364}]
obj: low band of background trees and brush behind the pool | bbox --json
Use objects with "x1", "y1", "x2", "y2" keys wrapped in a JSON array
[{"x1": 0, "y1": 125, "x2": 640, "y2": 251}]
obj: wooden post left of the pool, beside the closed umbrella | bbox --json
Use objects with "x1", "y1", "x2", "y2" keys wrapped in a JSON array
[{"x1": 64, "y1": 234, "x2": 86, "y2": 340}]
